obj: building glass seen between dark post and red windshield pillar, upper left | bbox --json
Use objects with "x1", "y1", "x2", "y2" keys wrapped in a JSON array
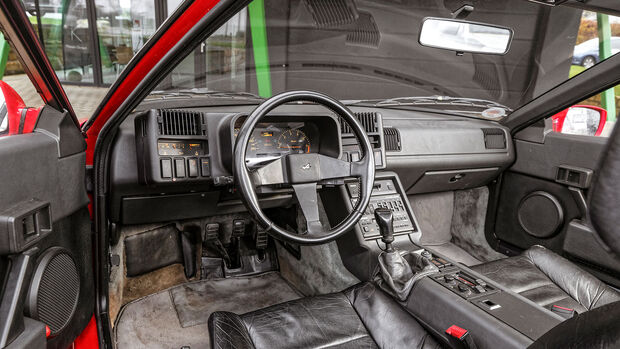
[{"x1": 95, "y1": 0, "x2": 157, "y2": 84}]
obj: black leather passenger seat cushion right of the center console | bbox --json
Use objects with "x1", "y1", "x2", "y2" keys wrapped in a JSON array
[{"x1": 472, "y1": 246, "x2": 620, "y2": 313}]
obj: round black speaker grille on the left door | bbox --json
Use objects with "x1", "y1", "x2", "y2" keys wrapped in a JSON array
[{"x1": 30, "y1": 250, "x2": 80, "y2": 334}]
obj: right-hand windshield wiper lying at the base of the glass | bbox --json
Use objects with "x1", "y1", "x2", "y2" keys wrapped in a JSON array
[{"x1": 354, "y1": 96, "x2": 512, "y2": 112}]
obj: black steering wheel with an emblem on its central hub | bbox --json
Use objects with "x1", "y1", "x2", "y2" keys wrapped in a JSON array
[{"x1": 233, "y1": 91, "x2": 375, "y2": 245}]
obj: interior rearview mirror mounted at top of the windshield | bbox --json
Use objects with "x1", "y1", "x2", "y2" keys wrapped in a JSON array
[{"x1": 418, "y1": 17, "x2": 512, "y2": 55}]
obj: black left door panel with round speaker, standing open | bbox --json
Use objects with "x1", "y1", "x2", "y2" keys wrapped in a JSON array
[{"x1": 0, "y1": 107, "x2": 94, "y2": 348}]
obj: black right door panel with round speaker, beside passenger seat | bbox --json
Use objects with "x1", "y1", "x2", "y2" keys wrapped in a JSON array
[{"x1": 494, "y1": 126, "x2": 620, "y2": 285}]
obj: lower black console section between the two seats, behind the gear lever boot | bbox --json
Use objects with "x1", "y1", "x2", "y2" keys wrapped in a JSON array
[{"x1": 405, "y1": 249, "x2": 564, "y2": 348}]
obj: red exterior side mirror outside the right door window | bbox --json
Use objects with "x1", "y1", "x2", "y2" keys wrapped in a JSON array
[{"x1": 552, "y1": 105, "x2": 607, "y2": 136}]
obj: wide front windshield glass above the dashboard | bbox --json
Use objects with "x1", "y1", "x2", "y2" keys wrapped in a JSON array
[{"x1": 152, "y1": 0, "x2": 620, "y2": 119}]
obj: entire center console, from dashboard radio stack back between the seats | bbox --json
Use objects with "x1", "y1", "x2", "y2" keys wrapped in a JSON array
[{"x1": 330, "y1": 172, "x2": 564, "y2": 348}]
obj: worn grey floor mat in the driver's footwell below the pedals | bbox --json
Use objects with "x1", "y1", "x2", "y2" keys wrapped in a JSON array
[{"x1": 114, "y1": 272, "x2": 301, "y2": 349}]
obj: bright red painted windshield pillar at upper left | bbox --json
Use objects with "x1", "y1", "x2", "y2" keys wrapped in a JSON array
[{"x1": 86, "y1": 0, "x2": 219, "y2": 165}]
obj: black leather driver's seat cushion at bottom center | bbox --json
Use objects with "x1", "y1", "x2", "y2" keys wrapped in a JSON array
[{"x1": 209, "y1": 283, "x2": 440, "y2": 349}]
